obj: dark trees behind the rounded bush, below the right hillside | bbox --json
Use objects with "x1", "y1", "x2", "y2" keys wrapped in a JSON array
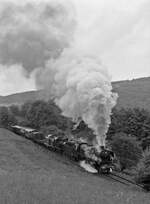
[{"x1": 107, "y1": 108, "x2": 150, "y2": 140}]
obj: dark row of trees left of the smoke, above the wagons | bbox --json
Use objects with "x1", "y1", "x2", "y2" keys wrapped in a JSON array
[{"x1": 0, "y1": 100, "x2": 70, "y2": 130}]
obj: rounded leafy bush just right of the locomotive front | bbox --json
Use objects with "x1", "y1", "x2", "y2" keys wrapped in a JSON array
[{"x1": 111, "y1": 133, "x2": 142, "y2": 170}]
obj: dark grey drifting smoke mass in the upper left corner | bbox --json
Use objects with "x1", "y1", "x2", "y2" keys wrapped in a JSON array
[{"x1": 0, "y1": 0, "x2": 75, "y2": 75}]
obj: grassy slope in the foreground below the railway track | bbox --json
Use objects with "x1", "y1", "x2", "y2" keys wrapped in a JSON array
[{"x1": 0, "y1": 129, "x2": 150, "y2": 204}]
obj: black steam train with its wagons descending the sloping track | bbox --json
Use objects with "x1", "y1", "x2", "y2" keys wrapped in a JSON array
[{"x1": 10, "y1": 125, "x2": 115, "y2": 174}]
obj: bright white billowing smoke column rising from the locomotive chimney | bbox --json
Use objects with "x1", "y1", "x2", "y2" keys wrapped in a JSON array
[{"x1": 37, "y1": 49, "x2": 117, "y2": 145}]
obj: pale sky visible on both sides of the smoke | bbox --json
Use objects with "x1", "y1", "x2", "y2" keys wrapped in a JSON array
[{"x1": 0, "y1": 0, "x2": 150, "y2": 95}]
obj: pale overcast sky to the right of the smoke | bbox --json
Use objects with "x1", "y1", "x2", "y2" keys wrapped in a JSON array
[{"x1": 74, "y1": 0, "x2": 150, "y2": 80}]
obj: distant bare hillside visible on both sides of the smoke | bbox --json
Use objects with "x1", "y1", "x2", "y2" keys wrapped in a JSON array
[{"x1": 0, "y1": 77, "x2": 150, "y2": 110}]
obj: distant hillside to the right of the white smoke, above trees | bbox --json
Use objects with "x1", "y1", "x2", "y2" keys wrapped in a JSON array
[{"x1": 113, "y1": 77, "x2": 150, "y2": 110}]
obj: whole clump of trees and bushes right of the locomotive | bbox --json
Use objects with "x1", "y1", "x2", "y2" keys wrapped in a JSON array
[{"x1": 107, "y1": 108, "x2": 150, "y2": 183}]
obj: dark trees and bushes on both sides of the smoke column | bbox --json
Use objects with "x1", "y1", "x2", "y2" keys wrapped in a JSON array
[{"x1": 0, "y1": 100, "x2": 150, "y2": 187}]
